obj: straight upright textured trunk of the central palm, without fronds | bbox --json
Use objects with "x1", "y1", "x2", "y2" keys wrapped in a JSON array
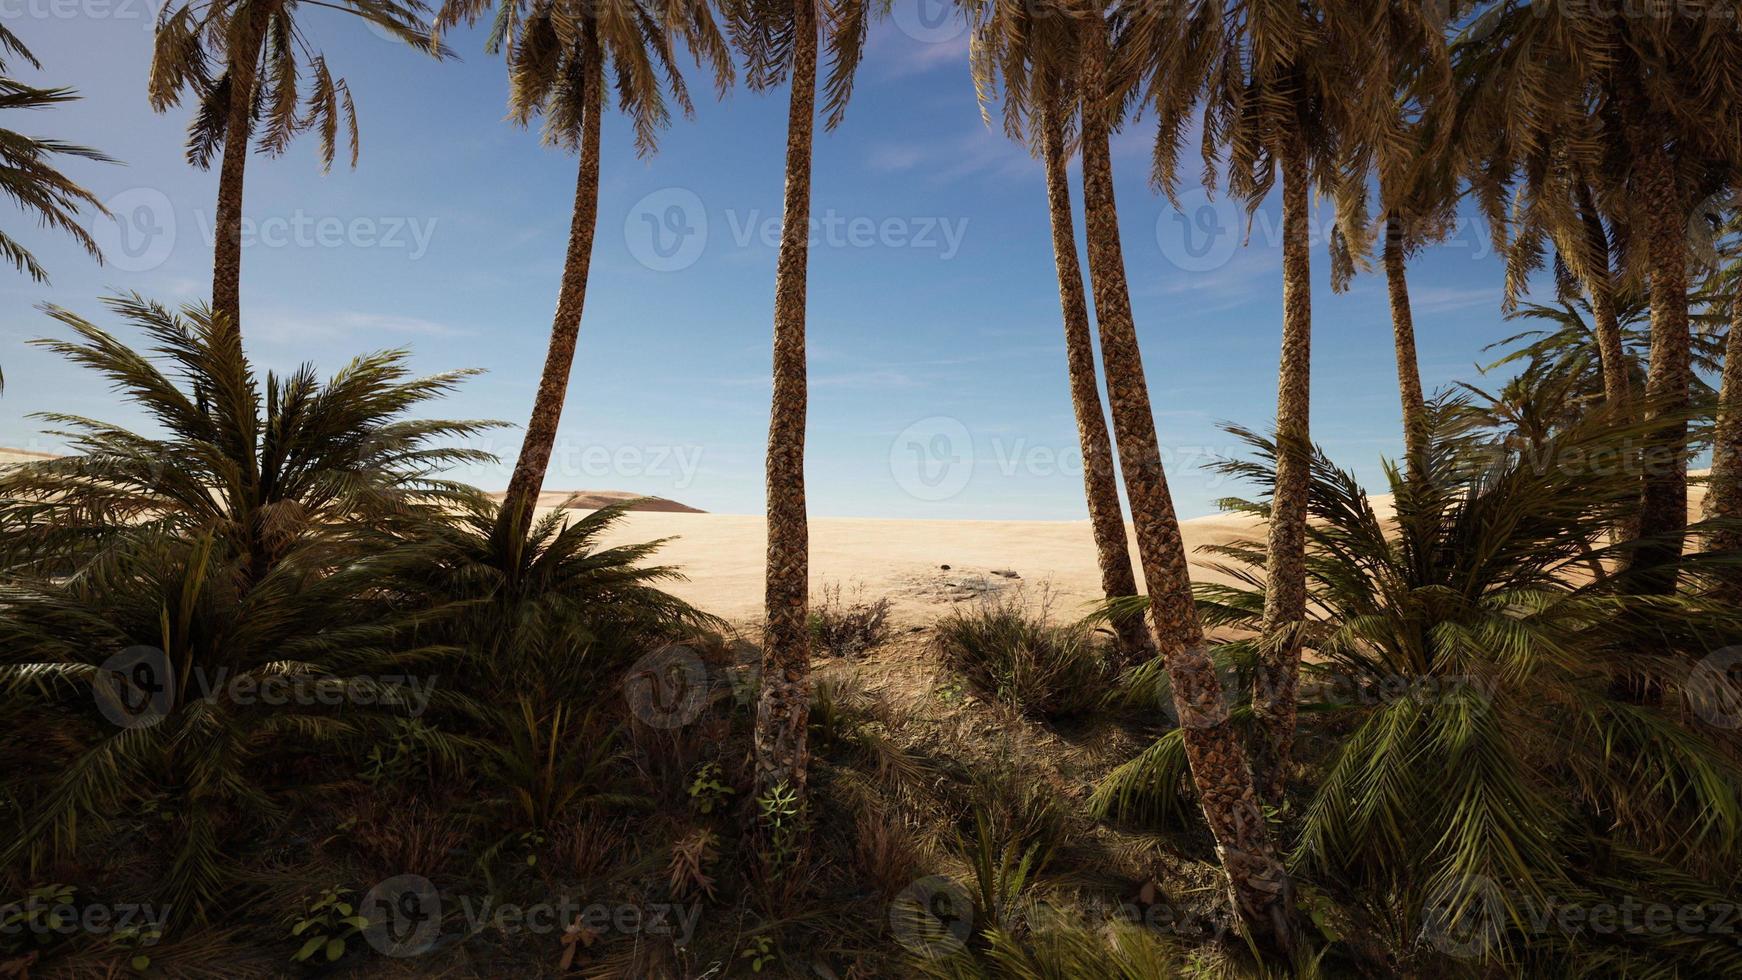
[{"x1": 754, "y1": 0, "x2": 817, "y2": 804}]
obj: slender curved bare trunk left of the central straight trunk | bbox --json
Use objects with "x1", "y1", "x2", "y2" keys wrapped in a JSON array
[{"x1": 502, "y1": 36, "x2": 604, "y2": 541}]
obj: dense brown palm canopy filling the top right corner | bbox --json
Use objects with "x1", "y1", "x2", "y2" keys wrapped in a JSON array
[{"x1": 1453, "y1": 0, "x2": 1742, "y2": 292}]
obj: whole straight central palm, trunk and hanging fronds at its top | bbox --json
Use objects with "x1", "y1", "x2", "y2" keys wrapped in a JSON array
[{"x1": 723, "y1": 0, "x2": 873, "y2": 811}]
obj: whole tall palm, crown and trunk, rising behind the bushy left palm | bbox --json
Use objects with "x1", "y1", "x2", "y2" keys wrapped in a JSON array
[{"x1": 148, "y1": 0, "x2": 446, "y2": 331}]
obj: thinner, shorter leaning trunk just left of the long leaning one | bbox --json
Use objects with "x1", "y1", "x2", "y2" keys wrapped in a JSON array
[{"x1": 1040, "y1": 101, "x2": 1155, "y2": 663}]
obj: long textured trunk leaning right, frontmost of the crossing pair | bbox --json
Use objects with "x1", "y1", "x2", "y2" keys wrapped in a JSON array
[{"x1": 1082, "y1": 19, "x2": 1293, "y2": 949}]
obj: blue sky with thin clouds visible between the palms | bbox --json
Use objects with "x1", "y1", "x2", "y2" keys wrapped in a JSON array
[{"x1": 0, "y1": 0, "x2": 1507, "y2": 520}]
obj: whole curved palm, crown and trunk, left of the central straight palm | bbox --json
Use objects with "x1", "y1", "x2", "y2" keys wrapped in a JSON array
[{"x1": 436, "y1": 0, "x2": 733, "y2": 540}]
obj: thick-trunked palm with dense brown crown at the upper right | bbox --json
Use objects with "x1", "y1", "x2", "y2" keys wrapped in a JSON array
[{"x1": 1456, "y1": 0, "x2": 1742, "y2": 594}]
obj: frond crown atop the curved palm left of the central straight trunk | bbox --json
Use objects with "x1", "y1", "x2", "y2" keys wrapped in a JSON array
[{"x1": 436, "y1": 0, "x2": 733, "y2": 155}]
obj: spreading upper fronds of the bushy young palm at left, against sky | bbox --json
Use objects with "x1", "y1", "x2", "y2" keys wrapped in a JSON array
[{"x1": 0, "y1": 296, "x2": 495, "y2": 580}]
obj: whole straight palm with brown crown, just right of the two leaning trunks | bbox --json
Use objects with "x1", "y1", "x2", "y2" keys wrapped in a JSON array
[{"x1": 1120, "y1": 0, "x2": 1397, "y2": 802}]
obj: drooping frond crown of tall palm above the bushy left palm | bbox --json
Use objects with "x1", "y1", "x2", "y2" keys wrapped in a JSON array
[{"x1": 148, "y1": 0, "x2": 449, "y2": 169}]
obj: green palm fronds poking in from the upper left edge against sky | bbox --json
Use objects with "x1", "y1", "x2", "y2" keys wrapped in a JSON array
[{"x1": 0, "y1": 28, "x2": 115, "y2": 282}]
